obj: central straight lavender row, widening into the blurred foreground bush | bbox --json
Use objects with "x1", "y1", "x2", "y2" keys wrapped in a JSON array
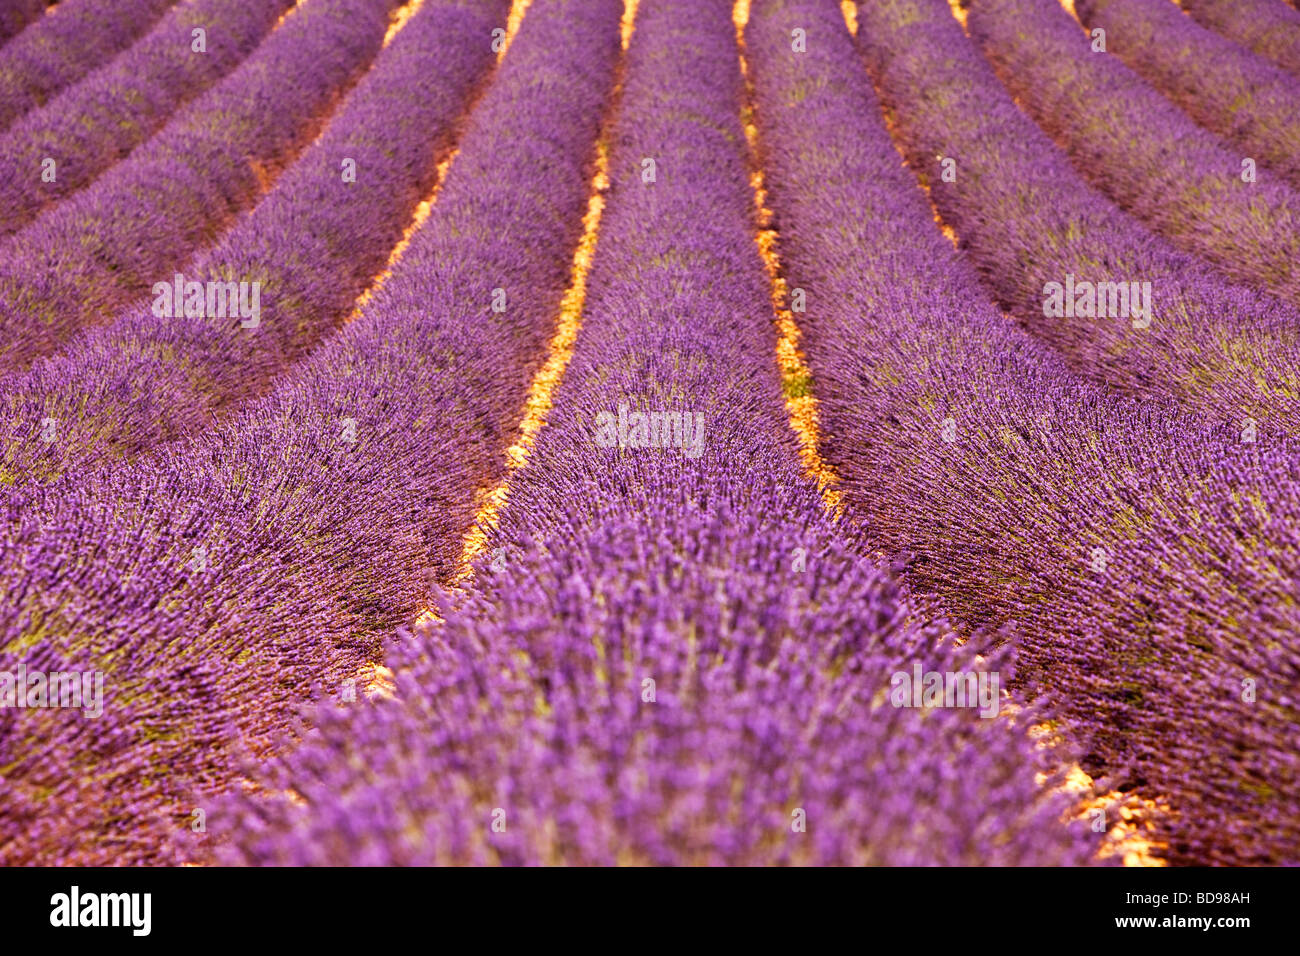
[{"x1": 212, "y1": 0, "x2": 1093, "y2": 865}]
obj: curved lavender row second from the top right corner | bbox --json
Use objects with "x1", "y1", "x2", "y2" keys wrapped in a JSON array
[{"x1": 1075, "y1": 0, "x2": 1300, "y2": 186}]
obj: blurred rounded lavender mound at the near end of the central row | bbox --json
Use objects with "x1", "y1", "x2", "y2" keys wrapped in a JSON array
[{"x1": 209, "y1": 546, "x2": 1093, "y2": 865}]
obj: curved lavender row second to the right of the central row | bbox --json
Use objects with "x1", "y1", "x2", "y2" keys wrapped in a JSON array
[{"x1": 858, "y1": 0, "x2": 1300, "y2": 434}]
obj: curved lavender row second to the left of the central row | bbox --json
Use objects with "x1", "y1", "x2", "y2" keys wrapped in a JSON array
[{"x1": 0, "y1": 0, "x2": 508, "y2": 484}]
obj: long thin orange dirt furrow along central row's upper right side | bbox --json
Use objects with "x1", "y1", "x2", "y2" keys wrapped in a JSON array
[{"x1": 732, "y1": 0, "x2": 849, "y2": 514}]
